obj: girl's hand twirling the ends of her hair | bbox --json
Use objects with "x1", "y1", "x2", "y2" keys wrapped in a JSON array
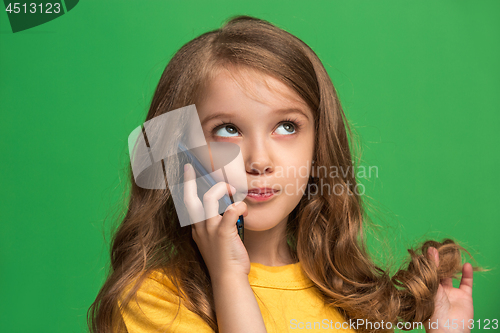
[{"x1": 425, "y1": 247, "x2": 474, "y2": 333}]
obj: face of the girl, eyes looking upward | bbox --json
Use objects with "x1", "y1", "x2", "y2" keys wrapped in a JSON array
[{"x1": 196, "y1": 69, "x2": 314, "y2": 231}]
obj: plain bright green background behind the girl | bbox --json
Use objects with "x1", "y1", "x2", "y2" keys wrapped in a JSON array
[{"x1": 0, "y1": 0, "x2": 500, "y2": 333}]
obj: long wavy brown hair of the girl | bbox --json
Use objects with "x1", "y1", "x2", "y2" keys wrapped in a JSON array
[{"x1": 88, "y1": 16, "x2": 478, "y2": 333}]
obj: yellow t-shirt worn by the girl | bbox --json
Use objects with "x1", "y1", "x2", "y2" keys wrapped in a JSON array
[{"x1": 122, "y1": 262, "x2": 355, "y2": 333}]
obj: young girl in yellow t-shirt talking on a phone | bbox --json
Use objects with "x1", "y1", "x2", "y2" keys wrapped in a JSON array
[{"x1": 89, "y1": 16, "x2": 473, "y2": 333}]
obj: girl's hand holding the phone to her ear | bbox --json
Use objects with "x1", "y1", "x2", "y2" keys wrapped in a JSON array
[{"x1": 184, "y1": 164, "x2": 250, "y2": 280}]
